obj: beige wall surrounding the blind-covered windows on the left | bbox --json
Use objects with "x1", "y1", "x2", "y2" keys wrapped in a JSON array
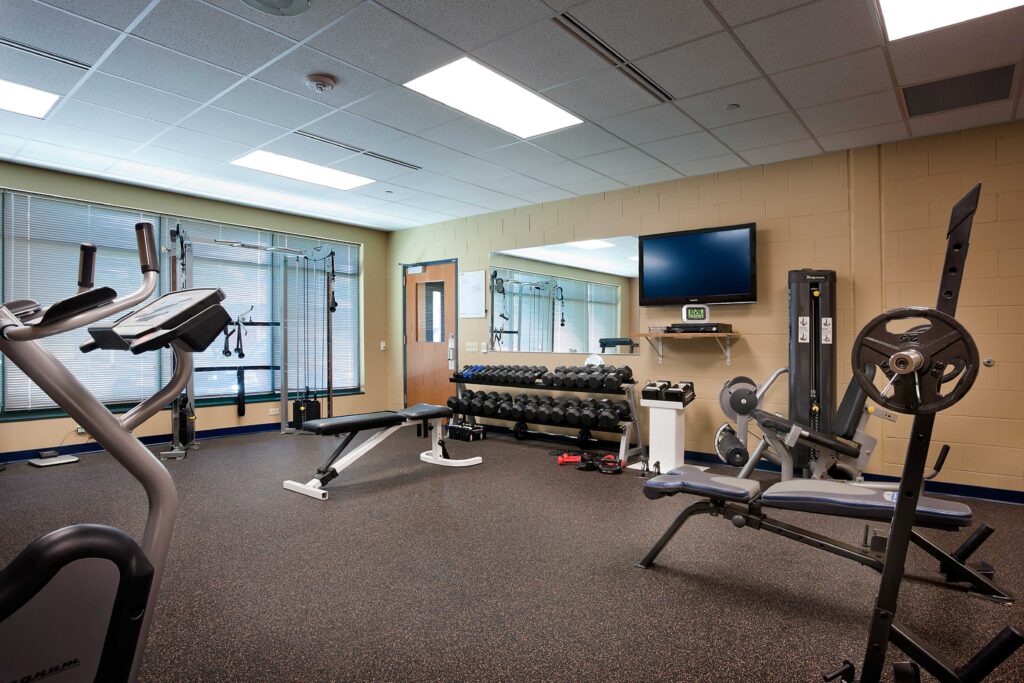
[{"x1": 0, "y1": 162, "x2": 391, "y2": 453}]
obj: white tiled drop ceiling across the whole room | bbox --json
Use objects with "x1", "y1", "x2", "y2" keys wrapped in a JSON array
[{"x1": 0, "y1": 0, "x2": 1024, "y2": 229}]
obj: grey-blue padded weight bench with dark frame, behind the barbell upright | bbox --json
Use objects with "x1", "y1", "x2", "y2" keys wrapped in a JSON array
[{"x1": 637, "y1": 464, "x2": 1014, "y2": 604}]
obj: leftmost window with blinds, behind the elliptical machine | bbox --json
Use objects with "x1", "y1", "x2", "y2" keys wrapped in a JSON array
[{"x1": 0, "y1": 193, "x2": 160, "y2": 413}]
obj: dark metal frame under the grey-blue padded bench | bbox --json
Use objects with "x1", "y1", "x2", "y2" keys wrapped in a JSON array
[{"x1": 636, "y1": 497, "x2": 1015, "y2": 605}]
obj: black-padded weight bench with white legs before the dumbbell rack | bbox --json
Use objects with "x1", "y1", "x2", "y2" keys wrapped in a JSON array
[{"x1": 285, "y1": 403, "x2": 483, "y2": 501}]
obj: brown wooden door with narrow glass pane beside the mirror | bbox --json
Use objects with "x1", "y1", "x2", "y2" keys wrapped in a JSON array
[{"x1": 406, "y1": 261, "x2": 458, "y2": 405}]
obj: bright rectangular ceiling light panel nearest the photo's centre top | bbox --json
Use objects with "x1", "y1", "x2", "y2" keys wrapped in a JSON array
[{"x1": 406, "y1": 57, "x2": 583, "y2": 137}]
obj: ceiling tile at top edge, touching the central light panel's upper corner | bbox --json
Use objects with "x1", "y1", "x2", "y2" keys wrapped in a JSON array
[{"x1": 379, "y1": 0, "x2": 553, "y2": 50}]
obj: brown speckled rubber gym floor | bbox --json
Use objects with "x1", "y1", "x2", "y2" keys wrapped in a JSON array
[{"x1": 0, "y1": 429, "x2": 1024, "y2": 683}]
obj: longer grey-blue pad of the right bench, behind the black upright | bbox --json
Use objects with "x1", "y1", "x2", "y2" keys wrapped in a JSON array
[{"x1": 761, "y1": 479, "x2": 973, "y2": 529}]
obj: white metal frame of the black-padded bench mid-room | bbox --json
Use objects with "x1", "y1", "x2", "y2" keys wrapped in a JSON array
[{"x1": 284, "y1": 413, "x2": 483, "y2": 501}]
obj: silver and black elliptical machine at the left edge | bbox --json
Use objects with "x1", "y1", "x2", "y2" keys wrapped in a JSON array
[{"x1": 0, "y1": 223, "x2": 230, "y2": 683}]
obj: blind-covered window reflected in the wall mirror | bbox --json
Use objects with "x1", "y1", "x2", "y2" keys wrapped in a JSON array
[{"x1": 492, "y1": 268, "x2": 620, "y2": 353}]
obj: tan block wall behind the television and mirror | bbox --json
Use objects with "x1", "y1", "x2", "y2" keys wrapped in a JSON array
[{"x1": 387, "y1": 123, "x2": 1024, "y2": 490}]
